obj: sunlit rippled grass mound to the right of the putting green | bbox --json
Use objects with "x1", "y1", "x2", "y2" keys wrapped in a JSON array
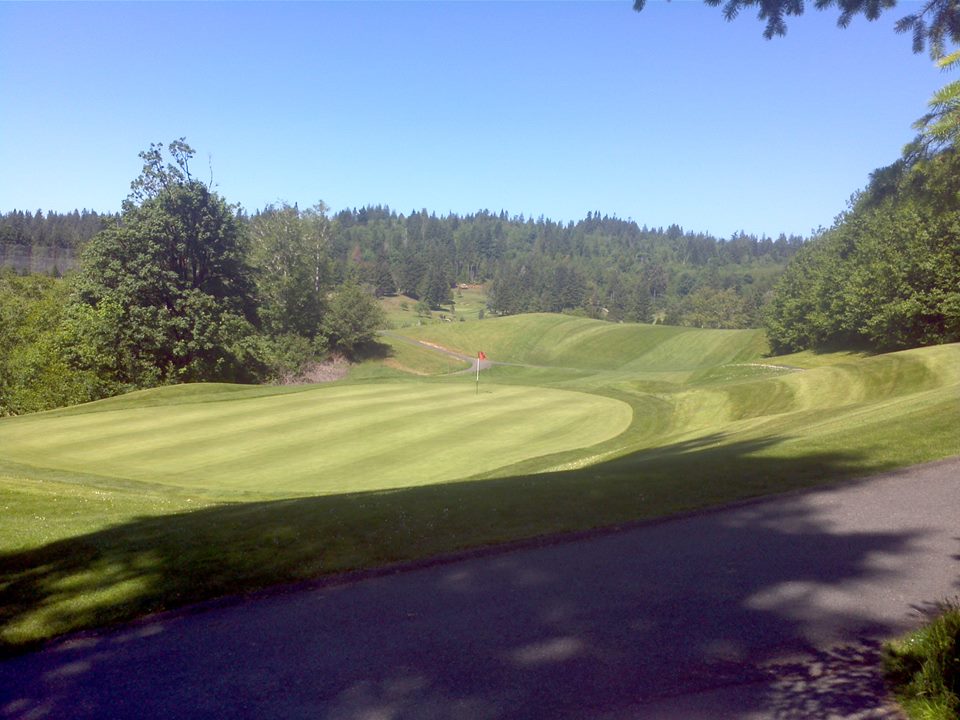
[{"x1": 644, "y1": 345, "x2": 960, "y2": 456}]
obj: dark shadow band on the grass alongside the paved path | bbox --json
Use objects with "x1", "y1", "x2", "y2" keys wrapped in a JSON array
[{"x1": 0, "y1": 436, "x2": 900, "y2": 650}]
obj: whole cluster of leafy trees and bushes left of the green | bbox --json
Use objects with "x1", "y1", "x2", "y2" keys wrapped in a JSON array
[{"x1": 0, "y1": 139, "x2": 383, "y2": 414}]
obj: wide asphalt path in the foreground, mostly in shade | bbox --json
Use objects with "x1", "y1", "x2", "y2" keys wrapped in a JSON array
[{"x1": 0, "y1": 458, "x2": 960, "y2": 720}]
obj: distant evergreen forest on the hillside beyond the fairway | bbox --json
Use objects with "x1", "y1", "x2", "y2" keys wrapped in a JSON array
[{"x1": 330, "y1": 207, "x2": 803, "y2": 327}]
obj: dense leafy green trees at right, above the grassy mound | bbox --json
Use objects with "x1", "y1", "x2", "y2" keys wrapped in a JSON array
[{"x1": 766, "y1": 149, "x2": 960, "y2": 352}]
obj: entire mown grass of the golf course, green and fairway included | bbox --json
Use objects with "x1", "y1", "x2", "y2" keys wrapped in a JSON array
[{"x1": 0, "y1": 314, "x2": 960, "y2": 653}]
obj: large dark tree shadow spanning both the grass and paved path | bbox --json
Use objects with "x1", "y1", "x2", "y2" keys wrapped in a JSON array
[{"x1": 0, "y1": 438, "x2": 952, "y2": 718}]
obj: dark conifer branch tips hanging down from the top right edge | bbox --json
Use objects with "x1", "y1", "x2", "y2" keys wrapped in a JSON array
[{"x1": 633, "y1": 0, "x2": 960, "y2": 58}]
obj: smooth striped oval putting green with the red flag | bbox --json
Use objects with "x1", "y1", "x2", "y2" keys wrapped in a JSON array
[{"x1": 0, "y1": 383, "x2": 633, "y2": 495}]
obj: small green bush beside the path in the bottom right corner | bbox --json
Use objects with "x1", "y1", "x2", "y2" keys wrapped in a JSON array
[{"x1": 883, "y1": 604, "x2": 960, "y2": 720}]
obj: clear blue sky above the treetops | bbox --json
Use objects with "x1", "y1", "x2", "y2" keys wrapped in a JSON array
[{"x1": 0, "y1": 0, "x2": 951, "y2": 237}]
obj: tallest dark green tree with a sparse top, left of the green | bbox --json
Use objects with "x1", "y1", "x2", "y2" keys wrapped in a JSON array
[{"x1": 72, "y1": 138, "x2": 256, "y2": 387}]
